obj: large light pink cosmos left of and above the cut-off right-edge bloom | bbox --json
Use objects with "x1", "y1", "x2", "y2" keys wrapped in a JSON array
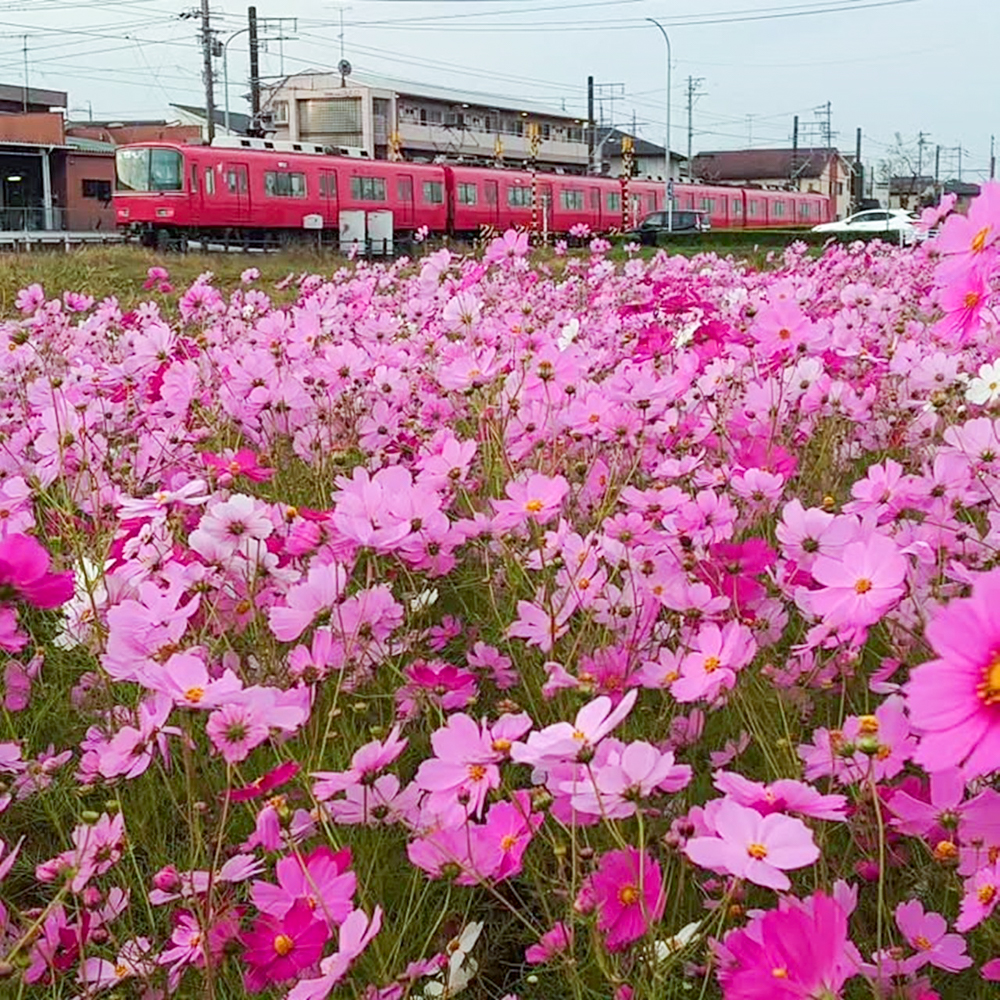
[{"x1": 796, "y1": 534, "x2": 907, "y2": 627}]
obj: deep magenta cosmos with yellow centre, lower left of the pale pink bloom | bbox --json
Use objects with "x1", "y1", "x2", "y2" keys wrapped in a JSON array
[{"x1": 587, "y1": 847, "x2": 667, "y2": 951}]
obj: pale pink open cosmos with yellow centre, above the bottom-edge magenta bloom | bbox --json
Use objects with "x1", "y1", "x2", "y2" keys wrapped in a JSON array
[{"x1": 684, "y1": 799, "x2": 819, "y2": 891}]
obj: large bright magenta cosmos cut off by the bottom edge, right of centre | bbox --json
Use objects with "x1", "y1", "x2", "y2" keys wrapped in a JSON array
[{"x1": 717, "y1": 892, "x2": 857, "y2": 1000}]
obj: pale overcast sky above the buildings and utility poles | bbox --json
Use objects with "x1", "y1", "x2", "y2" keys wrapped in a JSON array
[{"x1": 0, "y1": 0, "x2": 1000, "y2": 178}]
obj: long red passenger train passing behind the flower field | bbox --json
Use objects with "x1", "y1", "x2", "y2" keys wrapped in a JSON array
[{"x1": 114, "y1": 139, "x2": 832, "y2": 248}]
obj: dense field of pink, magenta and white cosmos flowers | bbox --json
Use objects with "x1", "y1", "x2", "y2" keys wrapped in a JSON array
[{"x1": 0, "y1": 186, "x2": 1000, "y2": 1000}]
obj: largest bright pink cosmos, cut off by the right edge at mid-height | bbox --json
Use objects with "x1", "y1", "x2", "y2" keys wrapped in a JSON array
[{"x1": 905, "y1": 570, "x2": 1000, "y2": 778}]
